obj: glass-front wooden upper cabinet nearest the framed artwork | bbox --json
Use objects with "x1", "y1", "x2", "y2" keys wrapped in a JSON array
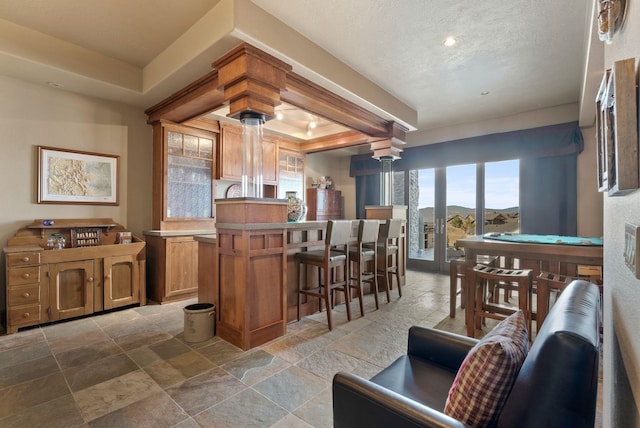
[{"x1": 154, "y1": 123, "x2": 217, "y2": 229}]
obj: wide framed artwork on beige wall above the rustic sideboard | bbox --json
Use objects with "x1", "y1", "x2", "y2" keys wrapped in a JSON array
[{"x1": 38, "y1": 146, "x2": 120, "y2": 205}]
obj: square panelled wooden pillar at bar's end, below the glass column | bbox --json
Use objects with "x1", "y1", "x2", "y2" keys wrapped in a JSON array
[{"x1": 216, "y1": 198, "x2": 287, "y2": 350}]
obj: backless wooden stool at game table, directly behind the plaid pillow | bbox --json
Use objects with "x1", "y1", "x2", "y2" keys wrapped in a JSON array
[{"x1": 467, "y1": 265, "x2": 533, "y2": 338}]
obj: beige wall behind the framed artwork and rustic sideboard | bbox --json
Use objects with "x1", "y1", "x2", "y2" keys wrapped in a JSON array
[{"x1": 0, "y1": 76, "x2": 151, "y2": 324}]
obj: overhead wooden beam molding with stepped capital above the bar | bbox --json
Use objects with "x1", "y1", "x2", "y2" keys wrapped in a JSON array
[{"x1": 145, "y1": 43, "x2": 408, "y2": 153}]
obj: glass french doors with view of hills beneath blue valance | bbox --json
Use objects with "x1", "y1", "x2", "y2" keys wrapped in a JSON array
[{"x1": 405, "y1": 160, "x2": 519, "y2": 273}]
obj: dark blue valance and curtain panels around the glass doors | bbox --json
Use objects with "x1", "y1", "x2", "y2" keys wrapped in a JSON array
[{"x1": 350, "y1": 122, "x2": 584, "y2": 235}]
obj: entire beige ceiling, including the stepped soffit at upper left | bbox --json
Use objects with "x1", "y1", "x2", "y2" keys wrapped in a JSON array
[{"x1": 0, "y1": 0, "x2": 591, "y2": 130}]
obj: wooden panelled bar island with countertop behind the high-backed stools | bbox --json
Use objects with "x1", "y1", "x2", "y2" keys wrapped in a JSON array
[{"x1": 194, "y1": 206, "x2": 405, "y2": 350}]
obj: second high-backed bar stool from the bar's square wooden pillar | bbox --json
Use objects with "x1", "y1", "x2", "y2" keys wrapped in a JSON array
[{"x1": 349, "y1": 220, "x2": 380, "y2": 310}]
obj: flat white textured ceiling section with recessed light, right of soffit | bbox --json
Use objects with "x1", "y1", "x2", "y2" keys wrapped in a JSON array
[{"x1": 253, "y1": 0, "x2": 588, "y2": 129}]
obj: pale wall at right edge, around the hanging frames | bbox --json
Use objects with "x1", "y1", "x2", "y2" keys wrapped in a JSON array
[{"x1": 603, "y1": 2, "x2": 640, "y2": 427}]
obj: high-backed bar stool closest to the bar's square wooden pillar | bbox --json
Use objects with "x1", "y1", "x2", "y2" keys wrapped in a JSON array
[{"x1": 294, "y1": 220, "x2": 362, "y2": 330}]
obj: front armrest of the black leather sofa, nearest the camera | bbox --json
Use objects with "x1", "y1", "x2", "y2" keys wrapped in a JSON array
[{"x1": 333, "y1": 372, "x2": 466, "y2": 428}]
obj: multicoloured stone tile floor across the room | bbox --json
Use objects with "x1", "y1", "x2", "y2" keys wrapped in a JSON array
[{"x1": 0, "y1": 271, "x2": 600, "y2": 428}]
